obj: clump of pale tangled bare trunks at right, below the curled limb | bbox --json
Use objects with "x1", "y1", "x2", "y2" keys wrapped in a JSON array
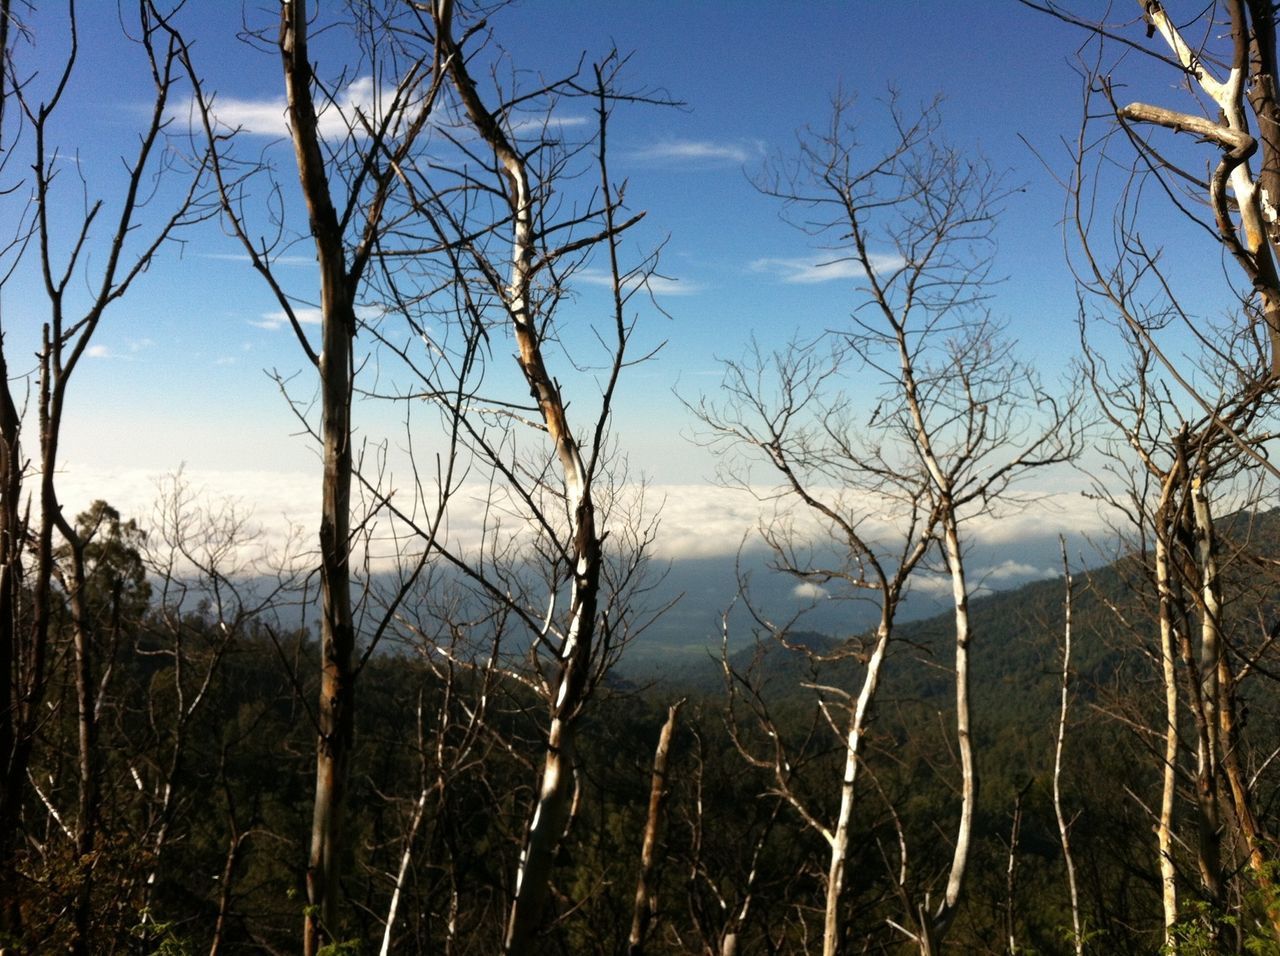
[{"x1": 1084, "y1": 310, "x2": 1274, "y2": 938}]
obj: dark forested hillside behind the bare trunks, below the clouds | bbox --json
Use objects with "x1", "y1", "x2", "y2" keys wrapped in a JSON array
[{"x1": 9, "y1": 506, "x2": 1280, "y2": 953}]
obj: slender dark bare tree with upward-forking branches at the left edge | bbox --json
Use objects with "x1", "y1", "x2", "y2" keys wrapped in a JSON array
[{"x1": 0, "y1": 0, "x2": 209, "y2": 952}]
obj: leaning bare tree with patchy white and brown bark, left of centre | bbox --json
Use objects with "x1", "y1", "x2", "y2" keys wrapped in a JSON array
[{"x1": 404, "y1": 0, "x2": 670, "y2": 952}]
